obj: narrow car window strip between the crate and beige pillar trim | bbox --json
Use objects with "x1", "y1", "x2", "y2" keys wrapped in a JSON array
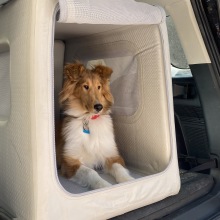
[{"x1": 166, "y1": 16, "x2": 192, "y2": 77}]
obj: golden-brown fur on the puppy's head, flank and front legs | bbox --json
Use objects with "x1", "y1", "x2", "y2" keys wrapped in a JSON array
[{"x1": 56, "y1": 62, "x2": 116, "y2": 178}]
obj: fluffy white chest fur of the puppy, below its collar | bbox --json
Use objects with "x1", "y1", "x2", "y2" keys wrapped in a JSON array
[{"x1": 63, "y1": 115, "x2": 118, "y2": 168}]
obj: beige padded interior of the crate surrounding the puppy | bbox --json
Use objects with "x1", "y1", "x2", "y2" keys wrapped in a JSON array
[{"x1": 54, "y1": 20, "x2": 171, "y2": 194}]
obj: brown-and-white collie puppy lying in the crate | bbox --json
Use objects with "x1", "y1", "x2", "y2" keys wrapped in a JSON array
[{"x1": 56, "y1": 63, "x2": 133, "y2": 189}]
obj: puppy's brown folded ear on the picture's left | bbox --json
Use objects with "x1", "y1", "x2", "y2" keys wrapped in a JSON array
[{"x1": 64, "y1": 62, "x2": 85, "y2": 82}]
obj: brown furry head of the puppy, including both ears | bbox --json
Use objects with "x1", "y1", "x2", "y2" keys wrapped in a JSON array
[{"x1": 60, "y1": 63, "x2": 113, "y2": 117}]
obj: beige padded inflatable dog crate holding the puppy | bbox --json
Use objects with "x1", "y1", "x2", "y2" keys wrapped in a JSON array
[{"x1": 0, "y1": 0, "x2": 180, "y2": 220}]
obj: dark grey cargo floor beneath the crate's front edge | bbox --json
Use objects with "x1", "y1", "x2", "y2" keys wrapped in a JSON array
[{"x1": 111, "y1": 173, "x2": 214, "y2": 220}]
